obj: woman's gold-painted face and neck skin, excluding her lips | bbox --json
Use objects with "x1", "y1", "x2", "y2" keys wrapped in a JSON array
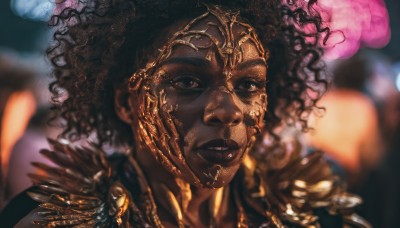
[{"x1": 116, "y1": 6, "x2": 267, "y2": 226}]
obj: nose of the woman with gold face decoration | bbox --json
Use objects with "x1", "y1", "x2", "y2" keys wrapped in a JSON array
[{"x1": 203, "y1": 88, "x2": 243, "y2": 126}]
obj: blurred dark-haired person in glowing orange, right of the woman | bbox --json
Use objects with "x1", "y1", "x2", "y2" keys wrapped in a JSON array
[{"x1": 309, "y1": 55, "x2": 383, "y2": 183}]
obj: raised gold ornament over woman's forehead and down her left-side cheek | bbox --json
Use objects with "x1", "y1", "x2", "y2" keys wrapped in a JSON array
[{"x1": 128, "y1": 5, "x2": 267, "y2": 189}]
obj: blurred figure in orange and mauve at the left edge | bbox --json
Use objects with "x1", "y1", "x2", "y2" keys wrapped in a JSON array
[{"x1": 0, "y1": 55, "x2": 55, "y2": 208}]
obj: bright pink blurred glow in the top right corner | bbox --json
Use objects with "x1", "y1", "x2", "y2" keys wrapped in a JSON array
[{"x1": 316, "y1": 0, "x2": 390, "y2": 59}]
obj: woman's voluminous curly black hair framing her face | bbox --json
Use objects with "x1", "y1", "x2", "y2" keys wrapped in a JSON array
[{"x1": 47, "y1": 0, "x2": 330, "y2": 144}]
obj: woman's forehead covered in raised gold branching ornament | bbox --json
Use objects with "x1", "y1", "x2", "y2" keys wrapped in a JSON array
[{"x1": 129, "y1": 5, "x2": 268, "y2": 91}]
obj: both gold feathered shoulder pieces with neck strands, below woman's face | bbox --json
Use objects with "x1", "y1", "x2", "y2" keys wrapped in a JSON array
[{"x1": 29, "y1": 140, "x2": 370, "y2": 227}]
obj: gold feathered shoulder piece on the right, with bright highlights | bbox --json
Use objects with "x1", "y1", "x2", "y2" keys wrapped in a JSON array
[{"x1": 260, "y1": 151, "x2": 371, "y2": 228}]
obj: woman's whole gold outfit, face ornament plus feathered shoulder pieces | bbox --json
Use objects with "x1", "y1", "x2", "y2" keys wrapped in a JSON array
[{"x1": 15, "y1": 2, "x2": 370, "y2": 228}]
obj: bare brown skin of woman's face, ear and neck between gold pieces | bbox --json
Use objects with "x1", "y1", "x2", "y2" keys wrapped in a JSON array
[{"x1": 116, "y1": 13, "x2": 266, "y2": 227}]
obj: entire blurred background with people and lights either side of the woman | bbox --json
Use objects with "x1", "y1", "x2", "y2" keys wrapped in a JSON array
[{"x1": 0, "y1": 0, "x2": 400, "y2": 227}]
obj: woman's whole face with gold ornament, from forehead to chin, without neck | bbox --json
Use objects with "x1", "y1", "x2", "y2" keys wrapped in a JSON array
[{"x1": 130, "y1": 5, "x2": 267, "y2": 187}]
